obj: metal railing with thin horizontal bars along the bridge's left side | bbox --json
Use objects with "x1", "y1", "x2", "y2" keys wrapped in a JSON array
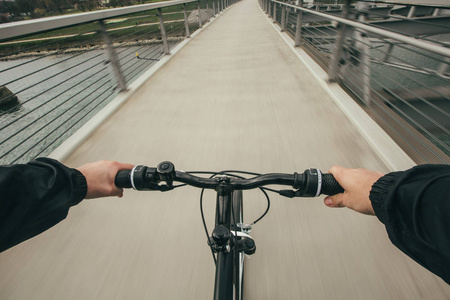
[{"x1": 0, "y1": 0, "x2": 235, "y2": 164}]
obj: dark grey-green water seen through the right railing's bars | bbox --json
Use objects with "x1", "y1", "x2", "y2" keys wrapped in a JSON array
[{"x1": 371, "y1": 37, "x2": 450, "y2": 156}]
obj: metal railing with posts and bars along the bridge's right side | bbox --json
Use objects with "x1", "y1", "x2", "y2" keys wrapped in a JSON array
[{"x1": 259, "y1": 0, "x2": 450, "y2": 164}]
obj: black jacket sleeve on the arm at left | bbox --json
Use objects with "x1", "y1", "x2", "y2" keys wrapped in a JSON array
[{"x1": 0, "y1": 158, "x2": 87, "y2": 252}]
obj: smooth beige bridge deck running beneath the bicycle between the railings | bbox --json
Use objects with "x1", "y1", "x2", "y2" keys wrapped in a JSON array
[{"x1": 0, "y1": 0, "x2": 450, "y2": 300}]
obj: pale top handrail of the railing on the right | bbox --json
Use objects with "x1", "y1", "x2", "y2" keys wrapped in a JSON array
[{"x1": 269, "y1": 0, "x2": 450, "y2": 57}]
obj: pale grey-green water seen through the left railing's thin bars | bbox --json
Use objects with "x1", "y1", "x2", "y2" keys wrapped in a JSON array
[{"x1": 0, "y1": 43, "x2": 167, "y2": 164}]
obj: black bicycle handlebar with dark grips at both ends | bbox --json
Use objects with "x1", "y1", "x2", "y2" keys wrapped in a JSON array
[{"x1": 115, "y1": 161, "x2": 344, "y2": 198}]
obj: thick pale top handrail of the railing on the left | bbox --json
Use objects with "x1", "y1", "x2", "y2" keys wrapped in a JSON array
[{"x1": 0, "y1": 0, "x2": 198, "y2": 41}]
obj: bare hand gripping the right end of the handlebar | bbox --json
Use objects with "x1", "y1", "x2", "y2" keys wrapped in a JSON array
[{"x1": 324, "y1": 166, "x2": 383, "y2": 215}]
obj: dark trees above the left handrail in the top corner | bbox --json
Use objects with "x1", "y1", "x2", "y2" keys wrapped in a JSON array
[{"x1": 0, "y1": 0, "x2": 145, "y2": 23}]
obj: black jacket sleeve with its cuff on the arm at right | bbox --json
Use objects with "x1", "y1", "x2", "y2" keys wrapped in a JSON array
[{"x1": 370, "y1": 165, "x2": 450, "y2": 284}]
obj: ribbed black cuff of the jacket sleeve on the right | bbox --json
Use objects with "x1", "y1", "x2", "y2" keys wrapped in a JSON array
[{"x1": 369, "y1": 172, "x2": 402, "y2": 224}]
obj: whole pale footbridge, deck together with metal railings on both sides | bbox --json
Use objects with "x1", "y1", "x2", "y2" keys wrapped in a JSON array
[{"x1": 0, "y1": 0, "x2": 450, "y2": 299}]
